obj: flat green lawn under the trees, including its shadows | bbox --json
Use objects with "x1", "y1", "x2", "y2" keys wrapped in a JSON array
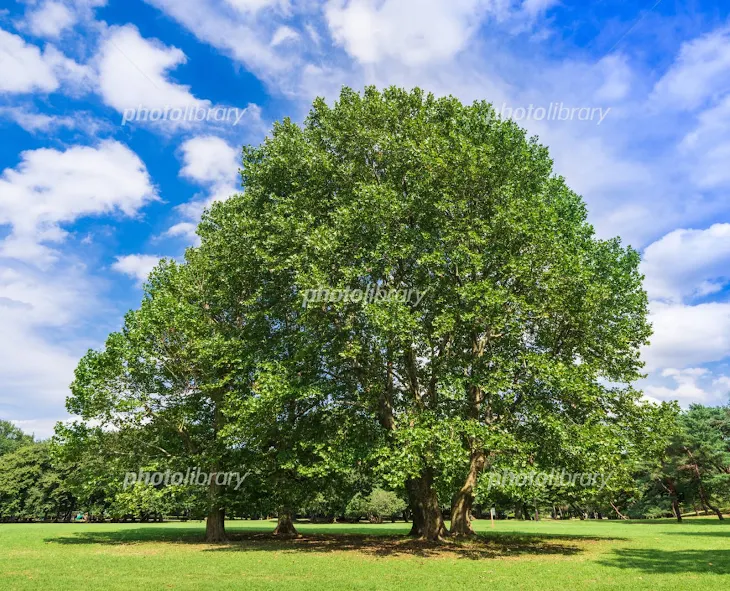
[{"x1": 0, "y1": 518, "x2": 730, "y2": 591}]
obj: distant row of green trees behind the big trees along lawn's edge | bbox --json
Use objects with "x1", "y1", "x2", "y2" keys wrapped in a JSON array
[{"x1": 0, "y1": 405, "x2": 730, "y2": 523}]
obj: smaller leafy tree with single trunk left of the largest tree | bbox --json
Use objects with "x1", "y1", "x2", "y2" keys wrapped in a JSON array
[{"x1": 65, "y1": 261, "x2": 250, "y2": 541}]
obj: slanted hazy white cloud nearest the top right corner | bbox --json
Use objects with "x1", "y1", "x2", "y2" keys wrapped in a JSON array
[{"x1": 653, "y1": 28, "x2": 730, "y2": 110}]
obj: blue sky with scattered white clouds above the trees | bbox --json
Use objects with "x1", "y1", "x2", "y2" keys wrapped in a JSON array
[{"x1": 0, "y1": 0, "x2": 730, "y2": 436}]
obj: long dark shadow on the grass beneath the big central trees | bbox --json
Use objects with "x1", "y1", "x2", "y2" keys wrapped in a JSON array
[{"x1": 45, "y1": 528, "x2": 616, "y2": 560}]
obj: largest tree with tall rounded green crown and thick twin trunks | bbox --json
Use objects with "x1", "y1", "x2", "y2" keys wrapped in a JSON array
[{"x1": 200, "y1": 88, "x2": 650, "y2": 539}]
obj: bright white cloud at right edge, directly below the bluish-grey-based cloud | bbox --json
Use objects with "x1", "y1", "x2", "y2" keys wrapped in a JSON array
[{"x1": 642, "y1": 302, "x2": 730, "y2": 371}]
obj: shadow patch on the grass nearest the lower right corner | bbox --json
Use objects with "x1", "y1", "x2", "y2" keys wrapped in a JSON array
[{"x1": 599, "y1": 549, "x2": 730, "y2": 575}]
